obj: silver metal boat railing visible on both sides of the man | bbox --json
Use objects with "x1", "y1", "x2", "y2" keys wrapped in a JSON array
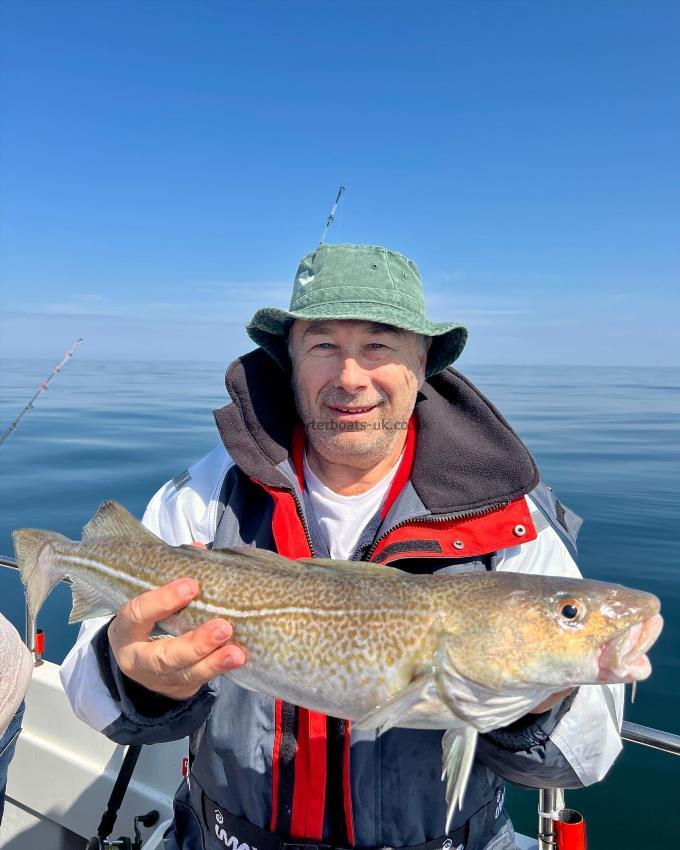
[{"x1": 0, "y1": 555, "x2": 680, "y2": 850}]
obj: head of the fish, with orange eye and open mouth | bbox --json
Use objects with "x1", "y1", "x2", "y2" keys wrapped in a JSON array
[{"x1": 438, "y1": 573, "x2": 663, "y2": 691}]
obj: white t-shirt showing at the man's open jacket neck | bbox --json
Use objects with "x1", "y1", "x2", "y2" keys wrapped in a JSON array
[{"x1": 303, "y1": 452, "x2": 401, "y2": 561}]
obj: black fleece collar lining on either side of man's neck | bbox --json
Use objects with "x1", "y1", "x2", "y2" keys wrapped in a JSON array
[{"x1": 214, "y1": 348, "x2": 539, "y2": 515}]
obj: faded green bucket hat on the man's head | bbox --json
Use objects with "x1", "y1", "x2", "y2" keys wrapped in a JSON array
[{"x1": 246, "y1": 245, "x2": 467, "y2": 377}]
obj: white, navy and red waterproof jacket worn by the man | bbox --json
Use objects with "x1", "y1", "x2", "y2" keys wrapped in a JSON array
[{"x1": 62, "y1": 350, "x2": 621, "y2": 850}]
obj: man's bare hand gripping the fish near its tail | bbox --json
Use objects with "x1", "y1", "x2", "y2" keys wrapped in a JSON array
[{"x1": 108, "y1": 578, "x2": 246, "y2": 700}]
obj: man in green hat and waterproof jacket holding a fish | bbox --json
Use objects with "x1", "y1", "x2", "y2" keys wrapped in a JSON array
[{"x1": 63, "y1": 245, "x2": 621, "y2": 850}]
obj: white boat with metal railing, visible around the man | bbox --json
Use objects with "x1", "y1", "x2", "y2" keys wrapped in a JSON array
[{"x1": 0, "y1": 557, "x2": 680, "y2": 850}]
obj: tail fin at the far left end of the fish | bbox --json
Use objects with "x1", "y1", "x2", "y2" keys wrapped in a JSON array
[{"x1": 12, "y1": 528, "x2": 71, "y2": 618}]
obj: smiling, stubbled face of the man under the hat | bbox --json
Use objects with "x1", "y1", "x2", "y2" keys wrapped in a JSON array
[{"x1": 289, "y1": 319, "x2": 427, "y2": 469}]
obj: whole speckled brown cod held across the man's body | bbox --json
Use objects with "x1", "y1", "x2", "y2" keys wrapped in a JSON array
[{"x1": 13, "y1": 501, "x2": 663, "y2": 832}]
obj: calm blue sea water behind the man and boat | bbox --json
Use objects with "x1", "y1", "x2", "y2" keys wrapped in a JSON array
[{"x1": 0, "y1": 353, "x2": 680, "y2": 850}]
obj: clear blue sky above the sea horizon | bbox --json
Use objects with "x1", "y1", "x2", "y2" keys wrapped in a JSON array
[{"x1": 0, "y1": 0, "x2": 680, "y2": 368}]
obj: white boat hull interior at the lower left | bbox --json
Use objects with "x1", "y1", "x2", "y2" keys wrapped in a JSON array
[{"x1": 0, "y1": 662, "x2": 188, "y2": 850}]
